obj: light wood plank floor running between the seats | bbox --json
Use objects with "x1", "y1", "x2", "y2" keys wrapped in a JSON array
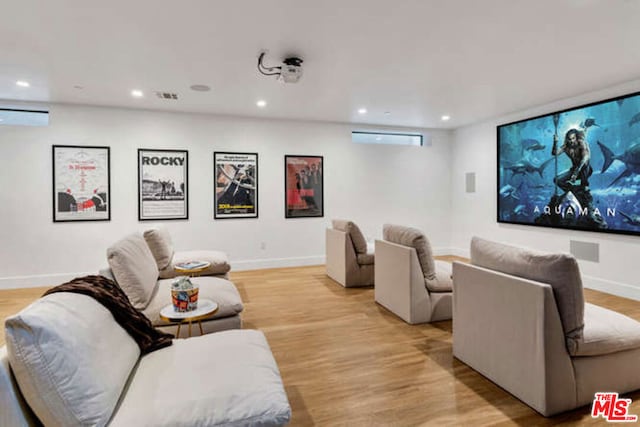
[{"x1": 0, "y1": 258, "x2": 640, "y2": 426}]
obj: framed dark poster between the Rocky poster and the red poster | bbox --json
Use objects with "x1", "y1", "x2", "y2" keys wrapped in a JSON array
[{"x1": 213, "y1": 152, "x2": 258, "y2": 219}]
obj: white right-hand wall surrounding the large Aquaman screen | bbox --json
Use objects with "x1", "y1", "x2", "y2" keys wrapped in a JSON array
[{"x1": 451, "y1": 81, "x2": 640, "y2": 300}]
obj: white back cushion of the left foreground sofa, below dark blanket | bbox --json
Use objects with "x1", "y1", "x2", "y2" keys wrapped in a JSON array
[{"x1": 5, "y1": 292, "x2": 140, "y2": 426}]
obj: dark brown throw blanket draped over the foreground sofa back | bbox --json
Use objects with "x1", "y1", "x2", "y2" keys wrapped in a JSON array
[{"x1": 43, "y1": 276, "x2": 173, "y2": 355}]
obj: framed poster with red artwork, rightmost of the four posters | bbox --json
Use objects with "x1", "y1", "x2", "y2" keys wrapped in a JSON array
[{"x1": 284, "y1": 155, "x2": 324, "y2": 218}]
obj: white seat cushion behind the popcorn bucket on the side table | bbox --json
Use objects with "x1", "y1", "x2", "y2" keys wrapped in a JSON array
[{"x1": 142, "y1": 276, "x2": 244, "y2": 326}]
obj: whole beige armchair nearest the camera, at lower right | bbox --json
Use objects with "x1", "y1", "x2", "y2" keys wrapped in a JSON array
[{"x1": 453, "y1": 238, "x2": 640, "y2": 416}]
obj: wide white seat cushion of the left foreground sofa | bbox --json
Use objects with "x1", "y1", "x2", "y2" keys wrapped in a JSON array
[{"x1": 110, "y1": 330, "x2": 291, "y2": 427}]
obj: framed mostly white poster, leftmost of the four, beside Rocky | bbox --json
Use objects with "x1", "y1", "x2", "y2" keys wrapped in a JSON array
[{"x1": 52, "y1": 145, "x2": 111, "y2": 222}]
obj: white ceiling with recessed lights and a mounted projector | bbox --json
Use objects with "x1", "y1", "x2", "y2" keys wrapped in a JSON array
[{"x1": 0, "y1": 0, "x2": 640, "y2": 128}]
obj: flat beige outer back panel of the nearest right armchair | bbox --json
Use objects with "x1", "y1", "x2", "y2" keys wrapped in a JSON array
[{"x1": 453, "y1": 262, "x2": 576, "y2": 416}]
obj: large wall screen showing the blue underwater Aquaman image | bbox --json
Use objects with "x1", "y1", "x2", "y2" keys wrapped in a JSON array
[{"x1": 498, "y1": 93, "x2": 640, "y2": 235}]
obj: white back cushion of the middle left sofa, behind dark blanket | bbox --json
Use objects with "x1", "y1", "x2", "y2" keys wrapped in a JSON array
[{"x1": 107, "y1": 234, "x2": 158, "y2": 310}]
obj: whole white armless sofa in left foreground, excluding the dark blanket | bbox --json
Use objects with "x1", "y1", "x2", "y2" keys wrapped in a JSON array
[{"x1": 0, "y1": 292, "x2": 291, "y2": 427}]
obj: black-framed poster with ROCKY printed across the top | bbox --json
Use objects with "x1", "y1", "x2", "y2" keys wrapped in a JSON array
[{"x1": 138, "y1": 148, "x2": 189, "y2": 221}]
